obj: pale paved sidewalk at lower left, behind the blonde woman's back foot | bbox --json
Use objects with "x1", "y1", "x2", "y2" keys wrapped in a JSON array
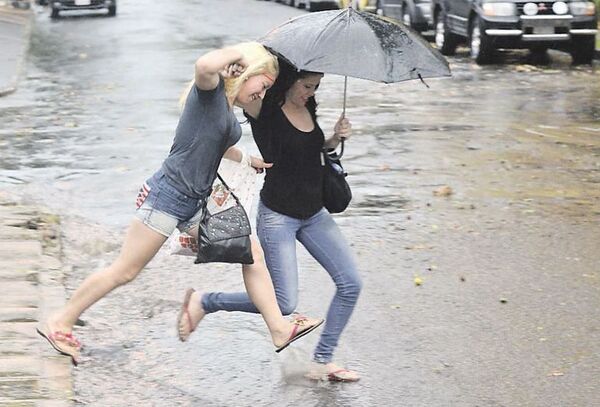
[{"x1": 0, "y1": 192, "x2": 73, "y2": 407}]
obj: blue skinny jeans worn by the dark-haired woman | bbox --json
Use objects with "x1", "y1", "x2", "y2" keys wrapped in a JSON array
[{"x1": 202, "y1": 202, "x2": 362, "y2": 363}]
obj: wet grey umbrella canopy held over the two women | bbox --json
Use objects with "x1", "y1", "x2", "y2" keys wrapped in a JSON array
[{"x1": 259, "y1": 8, "x2": 450, "y2": 83}]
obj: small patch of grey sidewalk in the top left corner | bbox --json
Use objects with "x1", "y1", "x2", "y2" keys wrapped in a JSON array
[{"x1": 0, "y1": 0, "x2": 34, "y2": 97}]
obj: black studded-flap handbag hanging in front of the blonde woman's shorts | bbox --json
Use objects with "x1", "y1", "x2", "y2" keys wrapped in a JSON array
[{"x1": 195, "y1": 173, "x2": 254, "y2": 264}]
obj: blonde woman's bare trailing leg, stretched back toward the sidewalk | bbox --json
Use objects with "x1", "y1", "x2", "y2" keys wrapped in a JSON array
[{"x1": 47, "y1": 219, "x2": 167, "y2": 333}]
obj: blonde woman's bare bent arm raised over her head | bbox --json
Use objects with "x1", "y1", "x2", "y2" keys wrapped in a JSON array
[{"x1": 194, "y1": 48, "x2": 248, "y2": 90}]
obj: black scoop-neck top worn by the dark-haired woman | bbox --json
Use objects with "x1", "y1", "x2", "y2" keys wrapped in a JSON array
[{"x1": 246, "y1": 107, "x2": 325, "y2": 219}]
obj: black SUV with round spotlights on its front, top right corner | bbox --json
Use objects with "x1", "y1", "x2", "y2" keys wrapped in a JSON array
[{"x1": 432, "y1": 0, "x2": 598, "y2": 64}]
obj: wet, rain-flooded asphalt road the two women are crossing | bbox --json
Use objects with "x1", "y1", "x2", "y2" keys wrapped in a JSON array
[{"x1": 0, "y1": 0, "x2": 600, "y2": 406}]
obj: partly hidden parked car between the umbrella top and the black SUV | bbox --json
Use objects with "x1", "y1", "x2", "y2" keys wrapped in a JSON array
[{"x1": 377, "y1": 0, "x2": 433, "y2": 32}]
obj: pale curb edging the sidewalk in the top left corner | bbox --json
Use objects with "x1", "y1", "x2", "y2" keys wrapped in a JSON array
[{"x1": 0, "y1": 2, "x2": 35, "y2": 97}]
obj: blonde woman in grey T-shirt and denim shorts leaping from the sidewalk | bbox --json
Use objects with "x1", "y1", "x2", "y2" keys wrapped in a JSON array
[{"x1": 37, "y1": 43, "x2": 323, "y2": 365}]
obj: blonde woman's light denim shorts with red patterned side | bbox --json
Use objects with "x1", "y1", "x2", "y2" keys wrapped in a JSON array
[{"x1": 135, "y1": 170, "x2": 206, "y2": 237}]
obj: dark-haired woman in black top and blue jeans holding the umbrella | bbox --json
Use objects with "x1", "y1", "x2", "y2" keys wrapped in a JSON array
[{"x1": 202, "y1": 61, "x2": 362, "y2": 381}]
